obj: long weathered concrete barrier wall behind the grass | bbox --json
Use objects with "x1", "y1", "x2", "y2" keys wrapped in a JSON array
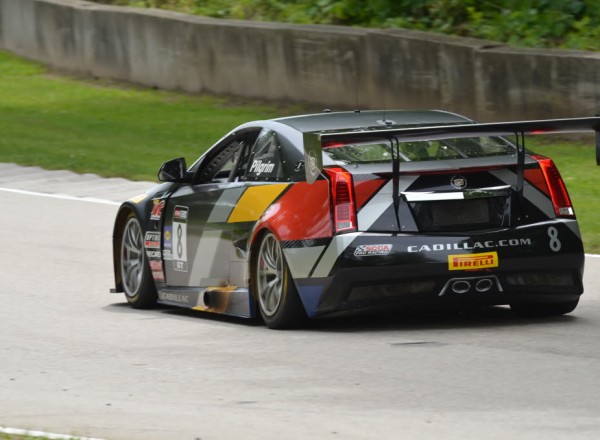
[{"x1": 0, "y1": 0, "x2": 600, "y2": 121}]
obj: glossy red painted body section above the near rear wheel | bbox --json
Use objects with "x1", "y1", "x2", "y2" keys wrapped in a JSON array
[{"x1": 256, "y1": 180, "x2": 332, "y2": 240}]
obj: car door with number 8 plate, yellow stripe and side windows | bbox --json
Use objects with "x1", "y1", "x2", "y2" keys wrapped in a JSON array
[{"x1": 163, "y1": 129, "x2": 287, "y2": 288}]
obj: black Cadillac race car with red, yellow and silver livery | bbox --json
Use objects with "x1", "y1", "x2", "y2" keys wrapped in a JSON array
[{"x1": 112, "y1": 110, "x2": 600, "y2": 329}]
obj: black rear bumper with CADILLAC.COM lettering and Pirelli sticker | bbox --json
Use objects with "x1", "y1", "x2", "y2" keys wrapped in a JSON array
[{"x1": 296, "y1": 221, "x2": 584, "y2": 316}]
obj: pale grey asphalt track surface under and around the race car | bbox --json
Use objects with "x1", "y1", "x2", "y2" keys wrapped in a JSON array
[{"x1": 0, "y1": 164, "x2": 600, "y2": 440}]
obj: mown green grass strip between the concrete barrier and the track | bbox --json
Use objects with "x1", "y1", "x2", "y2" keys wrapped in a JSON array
[{"x1": 0, "y1": 52, "x2": 600, "y2": 249}]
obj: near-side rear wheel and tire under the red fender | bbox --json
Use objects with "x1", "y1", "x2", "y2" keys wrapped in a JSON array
[{"x1": 253, "y1": 232, "x2": 306, "y2": 329}]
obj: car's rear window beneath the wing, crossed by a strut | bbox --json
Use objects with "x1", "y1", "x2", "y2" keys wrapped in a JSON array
[{"x1": 323, "y1": 136, "x2": 516, "y2": 164}]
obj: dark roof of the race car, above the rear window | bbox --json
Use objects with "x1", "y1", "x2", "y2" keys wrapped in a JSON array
[{"x1": 274, "y1": 110, "x2": 473, "y2": 133}]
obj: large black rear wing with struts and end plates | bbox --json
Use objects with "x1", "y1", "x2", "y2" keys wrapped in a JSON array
[{"x1": 303, "y1": 117, "x2": 600, "y2": 183}]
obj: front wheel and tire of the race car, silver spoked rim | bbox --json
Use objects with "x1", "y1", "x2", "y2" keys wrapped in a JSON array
[{"x1": 119, "y1": 213, "x2": 157, "y2": 309}]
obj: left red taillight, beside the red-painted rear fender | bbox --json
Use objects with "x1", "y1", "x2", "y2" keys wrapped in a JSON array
[{"x1": 325, "y1": 168, "x2": 356, "y2": 233}]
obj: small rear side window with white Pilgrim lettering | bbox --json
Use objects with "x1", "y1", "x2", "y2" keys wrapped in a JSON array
[{"x1": 245, "y1": 129, "x2": 284, "y2": 181}]
